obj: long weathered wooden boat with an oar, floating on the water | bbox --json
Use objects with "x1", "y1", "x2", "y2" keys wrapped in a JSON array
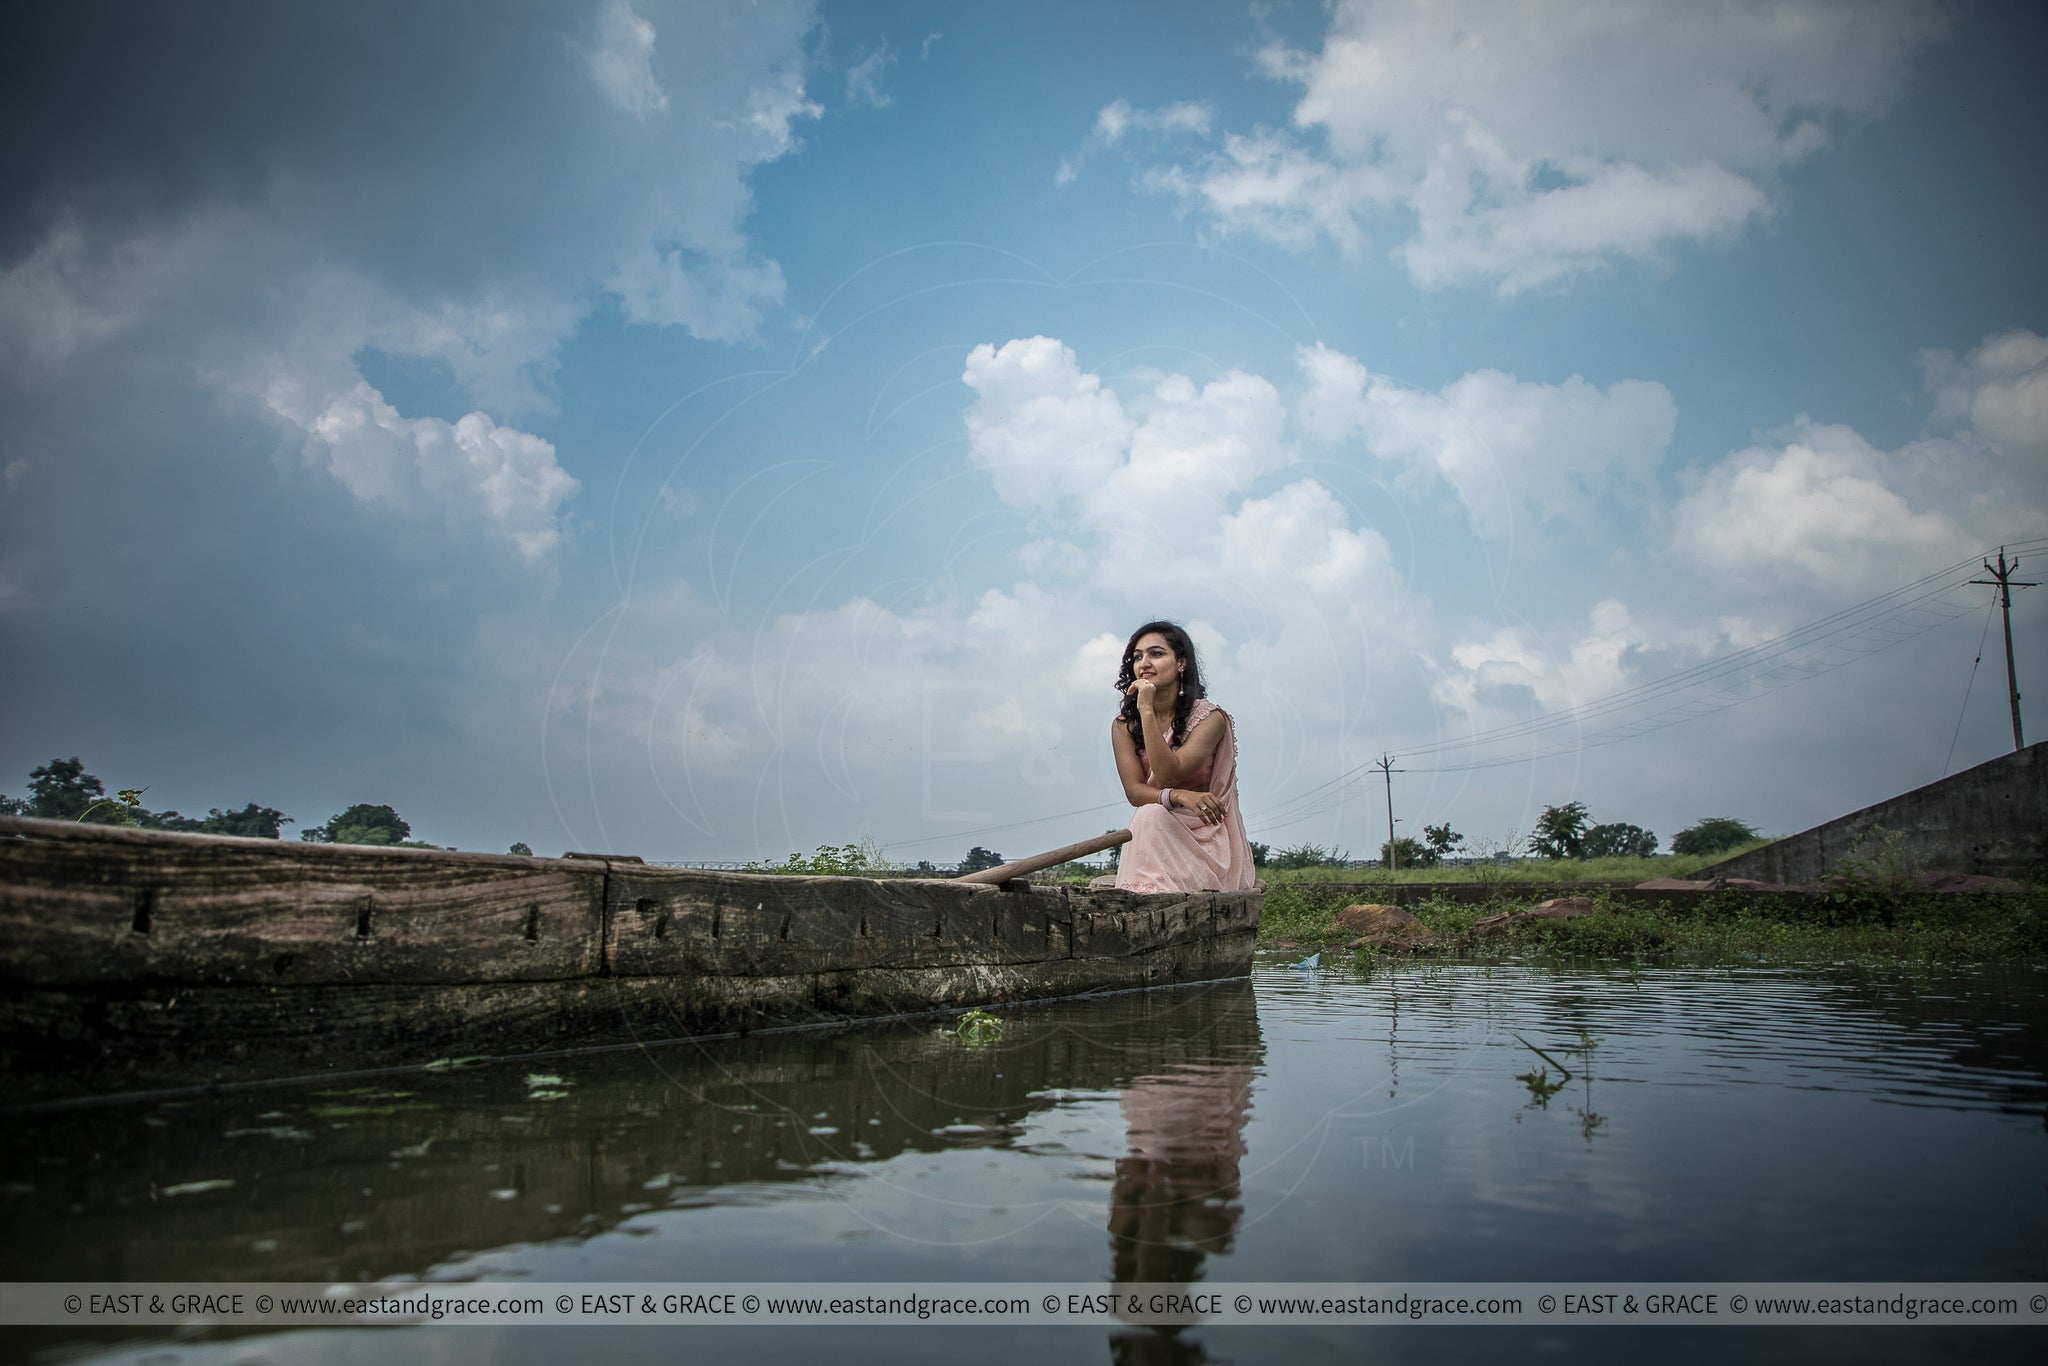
[{"x1": 0, "y1": 817, "x2": 1264, "y2": 1098}]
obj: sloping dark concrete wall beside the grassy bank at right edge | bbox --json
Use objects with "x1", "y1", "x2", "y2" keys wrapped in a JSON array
[{"x1": 1692, "y1": 741, "x2": 2048, "y2": 885}]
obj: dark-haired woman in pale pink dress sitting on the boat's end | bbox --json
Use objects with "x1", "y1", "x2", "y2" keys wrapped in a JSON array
[{"x1": 1110, "y1": 621, "x2": 1255, "y2": 891}]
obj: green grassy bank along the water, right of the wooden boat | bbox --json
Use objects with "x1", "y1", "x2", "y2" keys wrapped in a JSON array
[{"x1": 1260, "y1": 883, "x2": 2048, "y2": 963}]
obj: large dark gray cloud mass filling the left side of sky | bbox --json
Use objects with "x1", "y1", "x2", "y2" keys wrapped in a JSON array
[{"x1": 0, "y1": 0, "x2": 831, "y2": 842}]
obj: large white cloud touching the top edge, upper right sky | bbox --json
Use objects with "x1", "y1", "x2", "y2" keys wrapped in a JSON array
[{"x1": 1130, "y1": 0, "x2": 1946, "y2": 293}]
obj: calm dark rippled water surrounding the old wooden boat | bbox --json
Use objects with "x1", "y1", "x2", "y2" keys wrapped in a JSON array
[{"x1": 0, "y1": 967, "x2": 2048, "y2": 1366}]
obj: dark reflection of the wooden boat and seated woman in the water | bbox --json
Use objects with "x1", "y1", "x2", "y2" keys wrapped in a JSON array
[{"x1": 0, "y1": 981, "x2": 1260, "y2": 1282}]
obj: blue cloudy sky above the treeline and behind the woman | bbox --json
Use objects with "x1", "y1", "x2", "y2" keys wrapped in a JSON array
[{"x1": 0, "y1": 0, "x2": 2048, "y2": 862}]
